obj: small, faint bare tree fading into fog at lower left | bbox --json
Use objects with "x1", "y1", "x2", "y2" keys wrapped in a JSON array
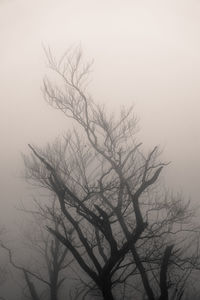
[{"x1": 1, "y1": 199, "x2": 73, "y2": 300}]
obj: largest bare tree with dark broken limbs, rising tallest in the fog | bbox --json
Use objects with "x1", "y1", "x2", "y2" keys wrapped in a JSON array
[{"x1": 24, "y1": 49, "x2": 200, "y2": 300}]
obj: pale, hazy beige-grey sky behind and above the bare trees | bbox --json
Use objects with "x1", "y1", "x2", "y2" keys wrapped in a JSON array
[{"x1": 0, "y1": 0, "x2": 200, "y2": 225}]
